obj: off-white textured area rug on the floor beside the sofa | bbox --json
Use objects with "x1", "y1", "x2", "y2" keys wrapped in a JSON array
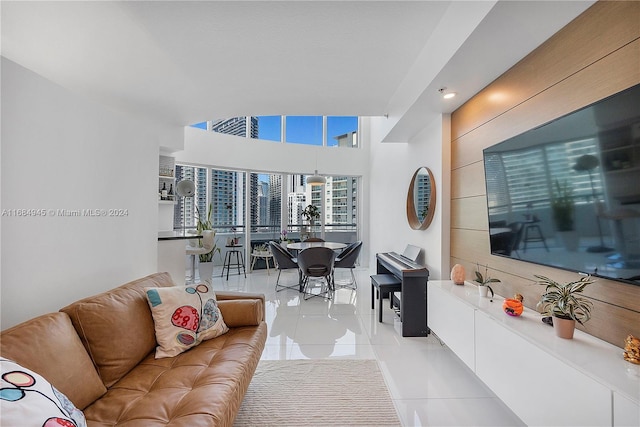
[{"x1": 234, "y1": 360, "x2": 400, "y2": 427}]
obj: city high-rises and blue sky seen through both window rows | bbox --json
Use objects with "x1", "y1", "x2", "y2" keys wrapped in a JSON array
[{"x1": 174, "y1": 116, "x2": 358, "y2": 244}]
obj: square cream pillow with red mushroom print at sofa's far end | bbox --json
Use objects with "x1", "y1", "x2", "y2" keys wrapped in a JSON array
[{"x1": 145, "y1": 283, "x2": 229, "y2": 359}]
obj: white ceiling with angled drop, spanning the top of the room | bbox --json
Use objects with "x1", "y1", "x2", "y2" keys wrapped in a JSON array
[{"x1": 1, "y1": 1, "x2": 593, "y2": 139}]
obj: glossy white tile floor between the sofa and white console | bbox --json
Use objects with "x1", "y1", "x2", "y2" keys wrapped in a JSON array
[{"x1": 206, "y1": 268, "x2": 524, "y2": 426}]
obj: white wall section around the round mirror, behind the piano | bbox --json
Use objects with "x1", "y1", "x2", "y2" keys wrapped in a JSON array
[{"x1": 369, "y1": 116, "x2": 451, "y2": 279}]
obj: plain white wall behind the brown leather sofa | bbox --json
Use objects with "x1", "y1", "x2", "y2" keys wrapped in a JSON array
[{"x1": 0, "y1": 58, "x2": 182, "y2": 329}]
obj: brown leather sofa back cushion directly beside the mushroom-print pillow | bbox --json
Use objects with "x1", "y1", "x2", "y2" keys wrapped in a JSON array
[{"x1": 61, "y1": 273, "x2": 174, "y2": 388}]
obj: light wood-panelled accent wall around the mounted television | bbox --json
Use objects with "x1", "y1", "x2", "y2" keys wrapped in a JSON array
[{"x1": 451, "y1": 1, "x2": 640, "y2": 347}]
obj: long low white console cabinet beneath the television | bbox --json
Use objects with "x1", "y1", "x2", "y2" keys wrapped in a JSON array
[{"x1": 427, "y1": 280, "x2": 640, "y2": 426}]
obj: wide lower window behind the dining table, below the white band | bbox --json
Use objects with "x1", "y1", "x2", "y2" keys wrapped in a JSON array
[{"x1": 174, "y1": 165, "x2": 359, "y2": 245}]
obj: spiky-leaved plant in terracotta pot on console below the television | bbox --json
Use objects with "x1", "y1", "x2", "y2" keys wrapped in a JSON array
[{"x1": 535, "y1": 275, "x2": 594, "y2": 339}]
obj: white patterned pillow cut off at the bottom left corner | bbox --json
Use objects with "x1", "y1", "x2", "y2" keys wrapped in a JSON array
[{"x1": 0, "y1": 356, "x2": 87, "y2": 427}]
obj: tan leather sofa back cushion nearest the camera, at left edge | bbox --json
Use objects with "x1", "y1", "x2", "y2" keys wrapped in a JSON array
[{"x1": 0, "y1": 313, "x2": 107, "y2": 409}]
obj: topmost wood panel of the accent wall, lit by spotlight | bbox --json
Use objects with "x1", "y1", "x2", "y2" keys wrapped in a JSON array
[{"x1": 451, "y1": 1, "x2": 640, "y2": 140}]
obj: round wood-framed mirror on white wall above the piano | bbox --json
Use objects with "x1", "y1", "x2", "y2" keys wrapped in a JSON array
[{"x1": 407, "y1": 167, "x2": 436, "y2": 230}]
